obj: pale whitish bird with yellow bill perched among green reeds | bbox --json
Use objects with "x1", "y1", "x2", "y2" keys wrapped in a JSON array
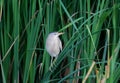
[{"x1": 46, "y1": 32, "x2": 63, "y2": 70}]
